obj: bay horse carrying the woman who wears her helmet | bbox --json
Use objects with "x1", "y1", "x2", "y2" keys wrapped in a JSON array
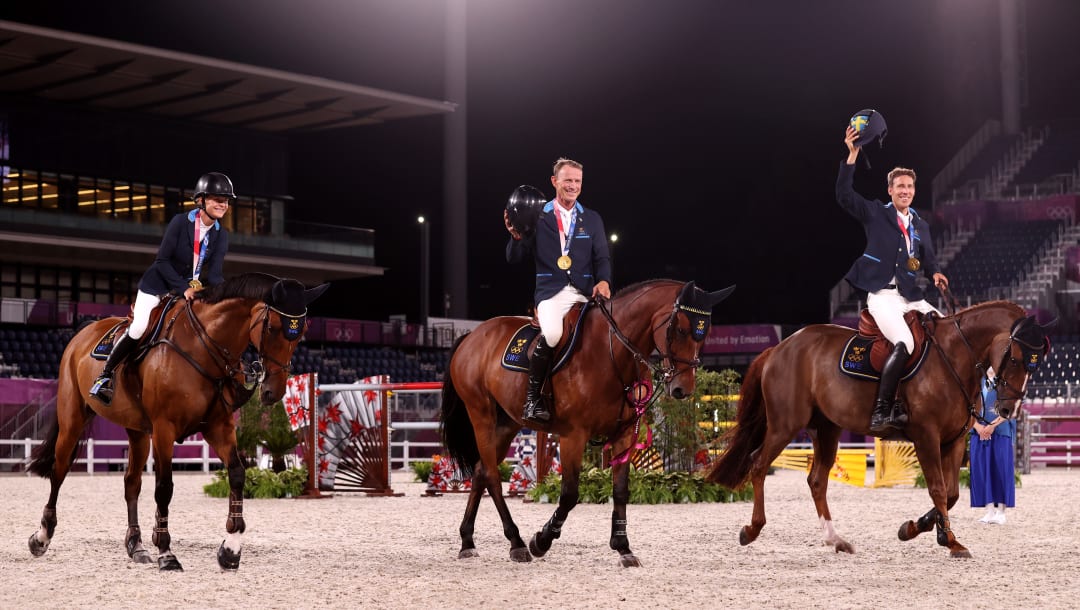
[{"x1": 27, "y1": 273, "x2": 328, "y2": 570}]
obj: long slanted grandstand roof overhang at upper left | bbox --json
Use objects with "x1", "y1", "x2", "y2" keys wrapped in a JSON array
[{"x1": 0, "y1": 21, "x2": 457, "y2": 133}]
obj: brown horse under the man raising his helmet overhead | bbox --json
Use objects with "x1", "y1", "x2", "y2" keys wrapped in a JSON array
[{"x1": 707, "y1": 301, "x2": 1050, "y2": 557}]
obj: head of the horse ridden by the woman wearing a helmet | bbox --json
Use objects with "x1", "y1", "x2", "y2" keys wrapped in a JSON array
[{"x1": 249, "y1": 280, "x2": 329, "y2": 405}]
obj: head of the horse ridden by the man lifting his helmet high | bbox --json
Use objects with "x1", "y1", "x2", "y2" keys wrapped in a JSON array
[{"x1": 990, "y1": 315, "x2": 1050, "y2": 419}]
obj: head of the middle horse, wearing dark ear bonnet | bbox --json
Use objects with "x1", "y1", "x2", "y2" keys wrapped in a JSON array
[{"x1": 653, "y1": 282, "x2": 735, "y2": 398}]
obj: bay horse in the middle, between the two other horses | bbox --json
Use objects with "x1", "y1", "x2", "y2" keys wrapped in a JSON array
[{"x1": 441, "y1": 280, "x2": 734, "y2": 567}]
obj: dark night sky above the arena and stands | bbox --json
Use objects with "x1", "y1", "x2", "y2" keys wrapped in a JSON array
[{"x1": 0, "y1": 0, "x2": 1080, "y2": 324}]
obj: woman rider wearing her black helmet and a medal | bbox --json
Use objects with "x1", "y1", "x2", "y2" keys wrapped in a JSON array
[{"x1": 90, "y1": 172, "x2": 237, "y2": 405}]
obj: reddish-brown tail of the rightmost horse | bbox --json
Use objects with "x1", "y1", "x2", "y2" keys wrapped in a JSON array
[{"x1": 705, "y1": 348, "x2": 772, "y2": 489}]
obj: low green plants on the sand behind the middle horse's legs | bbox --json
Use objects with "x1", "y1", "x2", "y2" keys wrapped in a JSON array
[{"x1": 528, "y1": 469, "x2": 754, "y2": 504}]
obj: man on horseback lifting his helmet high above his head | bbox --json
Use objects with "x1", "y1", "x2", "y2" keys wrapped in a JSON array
[{"x1": 836, "y1": 110, "x2": 948, "y2": 436}]
